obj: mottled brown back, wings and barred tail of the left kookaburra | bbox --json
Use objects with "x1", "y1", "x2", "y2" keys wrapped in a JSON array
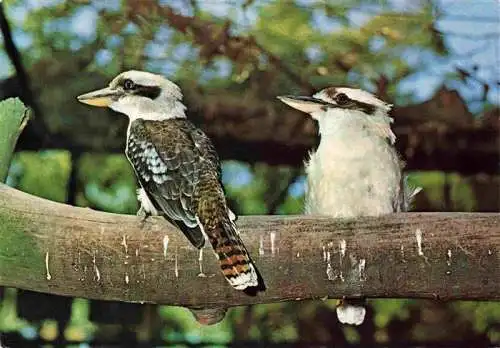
[{"x1": 126, "y1": 119, "x2": 258, "y2": 290}]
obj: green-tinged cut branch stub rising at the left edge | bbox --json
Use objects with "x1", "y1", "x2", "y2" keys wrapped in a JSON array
[{"x1": 0, "y1": 98, "x2": 28, "y2": 182}]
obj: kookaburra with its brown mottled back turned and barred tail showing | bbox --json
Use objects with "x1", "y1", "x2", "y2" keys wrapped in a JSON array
[{"x1": 78, "y1": 71, "x2": 260, "y2": 290}]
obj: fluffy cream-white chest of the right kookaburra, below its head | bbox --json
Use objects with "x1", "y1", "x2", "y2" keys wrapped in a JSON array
[{"x1": 306, "y1": 136, "x2": 401, "y2": 217}]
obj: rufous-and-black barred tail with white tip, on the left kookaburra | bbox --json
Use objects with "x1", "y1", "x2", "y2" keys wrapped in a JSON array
[{"x1": 201, "y1": 204, "x2": 259, "y2": 290}]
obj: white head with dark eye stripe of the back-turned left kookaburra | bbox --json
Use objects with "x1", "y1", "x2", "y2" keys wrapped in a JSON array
[{"x1": 78, "y1": 70, "x2": 186, "y2": 120}]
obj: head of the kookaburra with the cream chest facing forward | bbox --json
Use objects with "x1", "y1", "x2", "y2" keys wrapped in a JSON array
[{"x1": 278, "y1": 87, "x2": 395, "y2": 143}]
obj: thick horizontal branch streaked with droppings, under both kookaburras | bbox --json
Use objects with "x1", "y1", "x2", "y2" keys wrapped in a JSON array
[{"x1": 0, "y1": 185, "x2": 500, "y2": 307}]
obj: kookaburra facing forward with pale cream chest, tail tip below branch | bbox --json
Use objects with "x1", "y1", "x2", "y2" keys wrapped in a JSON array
[{"x1": 278, "y1": 87, "x2": 420, "y2": 325}]
